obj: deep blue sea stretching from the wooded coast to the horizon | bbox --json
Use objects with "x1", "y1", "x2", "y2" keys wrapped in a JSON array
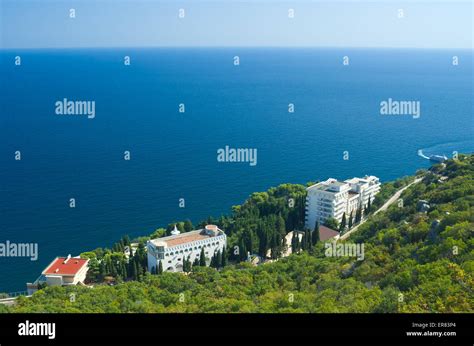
[{"x1": 0, "y1": 48, "x2": 473, "y2": 291}]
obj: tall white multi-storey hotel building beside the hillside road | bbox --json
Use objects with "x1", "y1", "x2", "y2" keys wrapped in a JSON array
[{"x1": 305, "y1": 176, "x2": 380, "y2": 229}]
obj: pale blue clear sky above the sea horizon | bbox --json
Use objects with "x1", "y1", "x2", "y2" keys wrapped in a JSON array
[{"x1": 0, "y1": 0, "x2": 474, "y2": 49}]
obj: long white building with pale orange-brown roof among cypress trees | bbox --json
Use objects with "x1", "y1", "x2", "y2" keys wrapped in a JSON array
[{"x1": 147, "y1": 225, "x2": 227, "y2": 272}]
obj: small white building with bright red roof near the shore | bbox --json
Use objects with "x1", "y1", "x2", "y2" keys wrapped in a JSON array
[{"x1": 26, "y1": 255, "x2": 89, "y2": 294}]
